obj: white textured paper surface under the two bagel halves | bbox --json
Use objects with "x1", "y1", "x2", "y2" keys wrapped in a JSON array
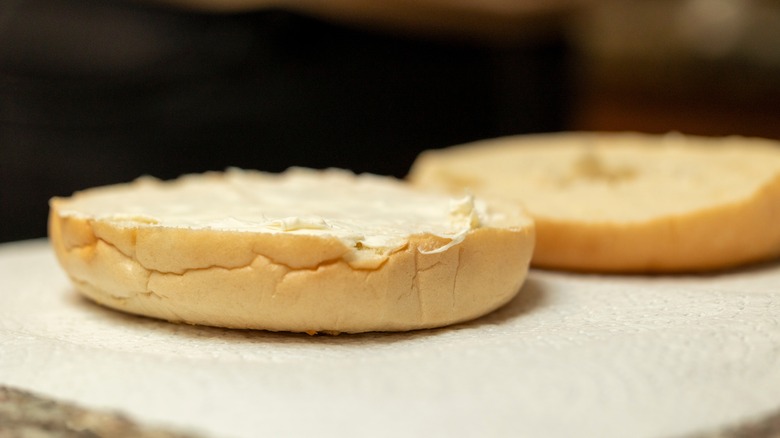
[{"x1": 0, "y1": 241, "x2": 780, "y2": 437}]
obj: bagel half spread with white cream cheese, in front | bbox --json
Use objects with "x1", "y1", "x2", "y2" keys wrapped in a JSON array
[{"x1": 49, "y1": 169, "x2": 534, "y2": 333}]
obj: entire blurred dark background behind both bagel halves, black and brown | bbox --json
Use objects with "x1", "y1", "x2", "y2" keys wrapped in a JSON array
[{"x1": 0, "y1": 0, "x2": 780, "y2": 241}]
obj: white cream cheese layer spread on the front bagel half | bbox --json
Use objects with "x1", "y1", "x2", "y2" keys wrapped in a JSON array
[{"x1": 61, "y1": 169, "x2": 488, "y2": 252}]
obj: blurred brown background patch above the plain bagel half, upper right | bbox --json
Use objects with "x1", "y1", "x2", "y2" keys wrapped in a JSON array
[{"x1": 572, "y1": 0, "x2": 780, "y2": 139}]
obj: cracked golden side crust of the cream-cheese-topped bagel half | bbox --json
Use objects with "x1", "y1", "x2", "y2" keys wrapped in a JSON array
[{"x1": 49, "y1": 173, "x2": 534, "y2": 332}]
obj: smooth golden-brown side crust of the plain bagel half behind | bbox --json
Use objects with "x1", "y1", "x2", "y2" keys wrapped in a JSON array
[{"x1": 532, "y1": 177, "x2": 780, "y2": 273}]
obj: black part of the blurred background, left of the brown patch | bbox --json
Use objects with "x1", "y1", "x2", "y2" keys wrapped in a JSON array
[{"x1": 0, "y1": 0, "x2": 569, "y2": 240}]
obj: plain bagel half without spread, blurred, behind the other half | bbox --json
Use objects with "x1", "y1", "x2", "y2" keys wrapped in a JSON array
[{"x1": 408, "y1": 132, "x2": 780, "y2": 273}]
